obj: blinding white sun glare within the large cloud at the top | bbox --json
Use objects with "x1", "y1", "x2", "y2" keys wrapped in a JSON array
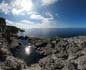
[{"x1": 11, "y1": 0, "x2": 33, "y2": 12}]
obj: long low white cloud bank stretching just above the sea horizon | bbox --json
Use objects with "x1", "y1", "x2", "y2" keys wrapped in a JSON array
[{"x1": 6, "y1": 19, "x2": 56, "y2": 30}]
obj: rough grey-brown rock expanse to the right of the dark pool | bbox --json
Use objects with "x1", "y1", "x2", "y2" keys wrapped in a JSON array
[{"x1": 27, "y1": 36, "x2": 86, "y2": 70}]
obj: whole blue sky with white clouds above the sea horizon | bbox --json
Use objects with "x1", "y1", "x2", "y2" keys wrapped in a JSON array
[{"x1": 0, "y1": 0, "x2": 86, "y2": 29}]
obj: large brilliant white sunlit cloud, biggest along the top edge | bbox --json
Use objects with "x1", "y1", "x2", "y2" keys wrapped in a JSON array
[{"x1": 11, "y1": 0, "x2": 33, "y2": 15}]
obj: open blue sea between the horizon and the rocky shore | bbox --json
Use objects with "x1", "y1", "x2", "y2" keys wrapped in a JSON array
[{"x1": 20, "y1": 28, "x2": 86, "y2": 37}]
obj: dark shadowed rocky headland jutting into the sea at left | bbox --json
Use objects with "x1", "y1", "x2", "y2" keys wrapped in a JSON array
[{"x1": 0, "y1": 17, "x2": 24, "y2": 38}]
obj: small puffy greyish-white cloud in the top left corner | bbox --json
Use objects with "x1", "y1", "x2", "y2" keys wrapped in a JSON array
[{"x1": 0, "y1": 1, "x2": 11, "y2": 14}]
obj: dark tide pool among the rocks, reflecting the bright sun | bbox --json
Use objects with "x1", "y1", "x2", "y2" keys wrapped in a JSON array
[{"x1": 11, "y1": 36, "x2": 40, "y2": 65}]
